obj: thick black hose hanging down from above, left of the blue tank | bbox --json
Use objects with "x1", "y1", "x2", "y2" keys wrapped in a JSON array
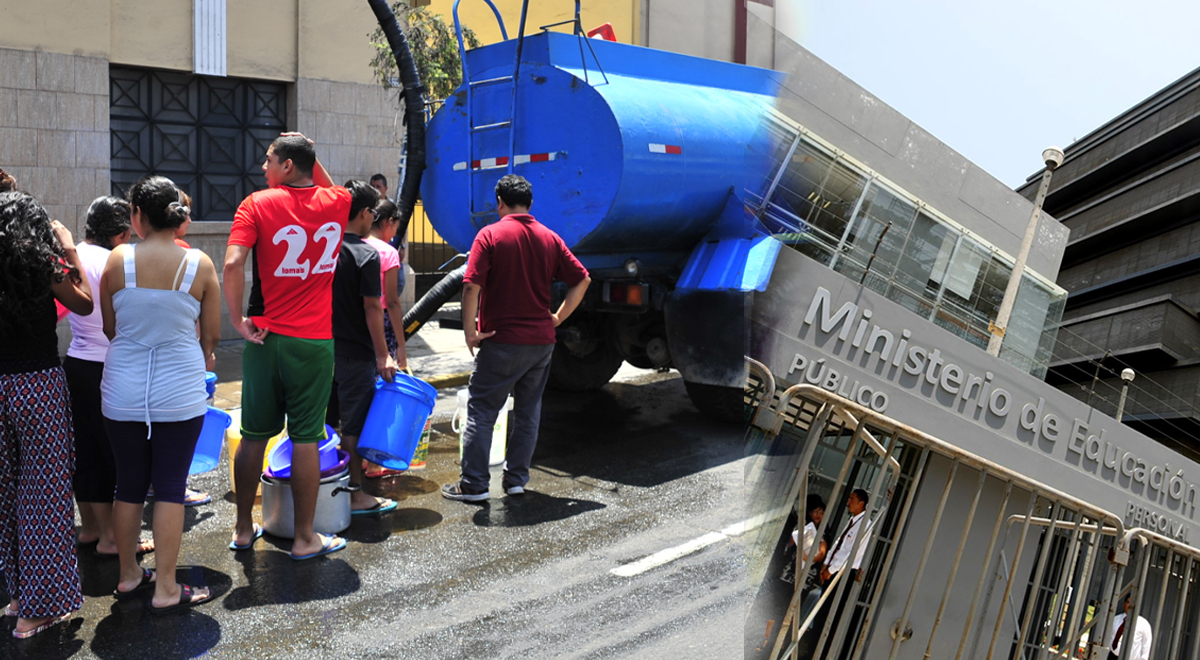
[{"x1": 367, "y1": 0, "x2": 425, "y2": 224}]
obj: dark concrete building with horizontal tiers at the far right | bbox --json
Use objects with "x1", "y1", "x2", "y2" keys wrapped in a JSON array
[{"x1": 1019, "y1": 70, "x2": 1200, "y2": 457}]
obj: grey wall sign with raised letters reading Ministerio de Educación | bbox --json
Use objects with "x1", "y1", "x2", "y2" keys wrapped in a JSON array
[{"x1": 750, "y1": 250, "x2": 1200, "y2": 545}]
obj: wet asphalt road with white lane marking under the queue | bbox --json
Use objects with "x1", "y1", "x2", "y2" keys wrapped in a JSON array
[{"x1": 0, "y1": 372, "x2": 745, "y2": 660}]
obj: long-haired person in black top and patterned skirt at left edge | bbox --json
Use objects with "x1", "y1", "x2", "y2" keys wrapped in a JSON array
[{"x1": 0, "y1": 192, "x2": 92, "y2": 638}]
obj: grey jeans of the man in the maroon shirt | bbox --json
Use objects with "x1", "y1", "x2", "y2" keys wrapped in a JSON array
[{"x1": 462, "y1": 340, "x2": 554, "y2": 488}]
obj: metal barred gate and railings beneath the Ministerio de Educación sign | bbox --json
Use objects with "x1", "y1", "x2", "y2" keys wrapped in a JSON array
[{"x1": 745, "y1": 359, "x2": 1200, "y2": 660}]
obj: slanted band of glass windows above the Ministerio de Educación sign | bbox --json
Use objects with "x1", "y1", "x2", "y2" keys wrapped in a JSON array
[{"x1": 752, "y1": 118, "x2": 1067, "y2": 378}]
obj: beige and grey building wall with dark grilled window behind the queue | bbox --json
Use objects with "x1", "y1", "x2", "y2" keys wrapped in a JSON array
[{"x1": 0, "y1": 0, "x2": 400, "y2": 338}]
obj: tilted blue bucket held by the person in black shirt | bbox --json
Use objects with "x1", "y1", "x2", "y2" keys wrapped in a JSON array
[{"x1": 359, "y1": 373, "x2": 438, "y2": 469}]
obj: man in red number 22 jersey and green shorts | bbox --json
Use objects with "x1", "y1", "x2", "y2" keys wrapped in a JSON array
[{"x1": 224, "y1": 133, "x2": 350, "y2": 559}]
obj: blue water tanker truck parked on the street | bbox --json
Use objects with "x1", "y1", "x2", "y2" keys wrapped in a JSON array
[{"x1": 420, "y1": 2, "x2": 779, "y2": 418}]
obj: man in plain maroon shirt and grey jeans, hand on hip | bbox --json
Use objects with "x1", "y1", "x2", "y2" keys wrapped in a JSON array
[{"x1": 442, "y1": 174, "x2": 592, "y2": 502}]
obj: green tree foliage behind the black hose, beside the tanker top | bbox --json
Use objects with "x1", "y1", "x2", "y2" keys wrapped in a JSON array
[{"x1": 371, "y1": 1, "x2": 479, "y2": 100}]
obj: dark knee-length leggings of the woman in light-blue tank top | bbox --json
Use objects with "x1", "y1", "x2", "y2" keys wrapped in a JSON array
[{"x1": 104, "y1": 415, "x2": 204, "y2": 504}]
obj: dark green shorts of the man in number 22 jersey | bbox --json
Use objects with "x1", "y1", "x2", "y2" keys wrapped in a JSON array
[{"x1": 241, "y1": 332, "x2": 334, "y2": 444}]
